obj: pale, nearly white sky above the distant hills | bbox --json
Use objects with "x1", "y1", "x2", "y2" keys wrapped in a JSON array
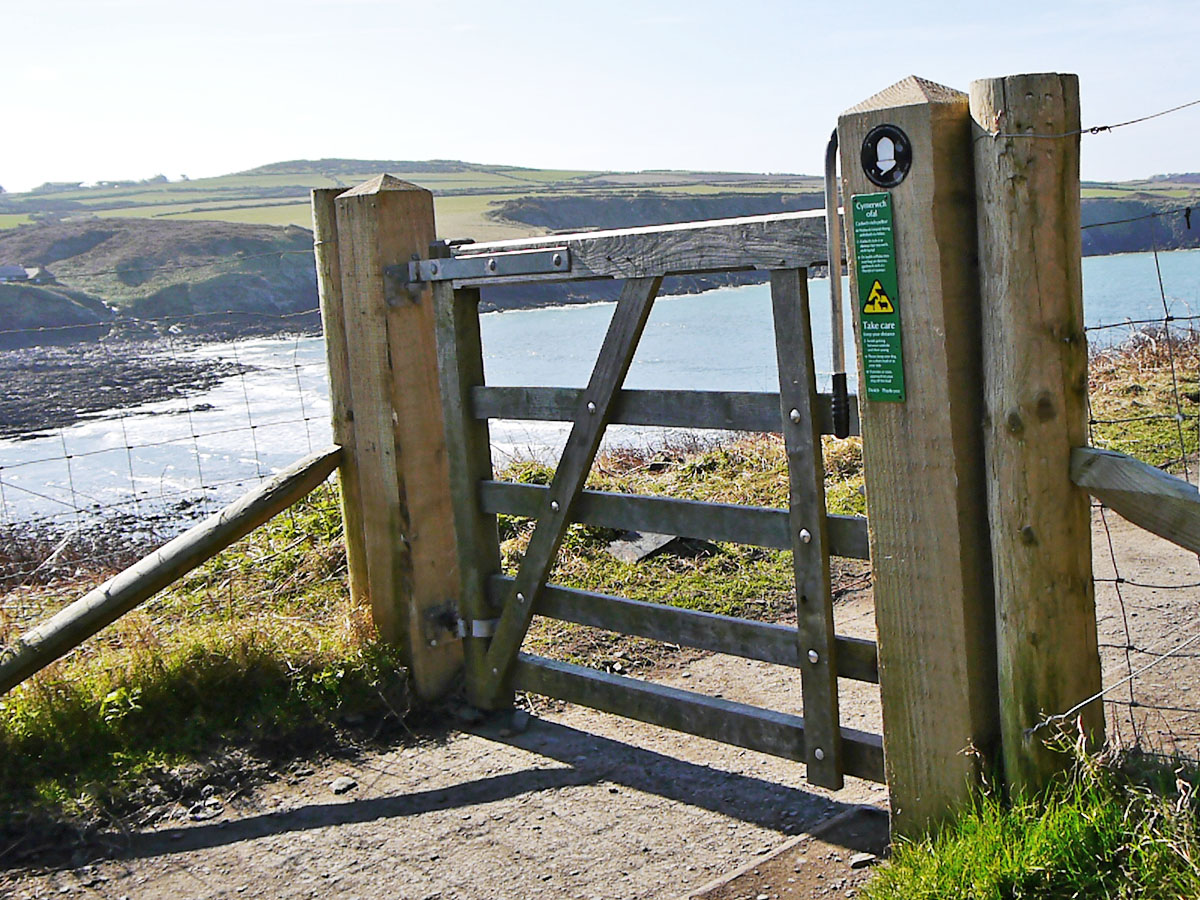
[{"x1": 0, "y1": 0, "x2": 1200, "y2": 191}]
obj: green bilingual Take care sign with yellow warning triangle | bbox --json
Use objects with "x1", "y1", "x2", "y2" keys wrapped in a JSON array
[{"x1": 851, "y1": 193, "x2": 904, "y2": 403}]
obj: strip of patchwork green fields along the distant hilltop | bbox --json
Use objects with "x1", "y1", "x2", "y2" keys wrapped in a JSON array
[{"x1": 0, "y1": 160, "x2": 1200, "y2": 260}]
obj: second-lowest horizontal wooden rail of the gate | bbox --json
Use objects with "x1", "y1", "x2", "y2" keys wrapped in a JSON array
[{"x1": 488, "y1": 575, "x2": 880, "y2": 684}]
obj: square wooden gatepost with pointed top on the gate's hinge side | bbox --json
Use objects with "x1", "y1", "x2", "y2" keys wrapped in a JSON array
[{"x1": 336, "y1": 175, "x2": 462, "y2": 697}]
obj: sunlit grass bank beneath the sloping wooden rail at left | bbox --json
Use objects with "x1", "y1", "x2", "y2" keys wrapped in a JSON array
[{"x1": 0, "y1": 487, "x2": 406, "y2": 818}]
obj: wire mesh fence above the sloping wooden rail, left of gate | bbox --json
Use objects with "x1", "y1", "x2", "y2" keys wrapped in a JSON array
[{"x1": 0, "y1": 308, "x2": 338, "y2": 643}]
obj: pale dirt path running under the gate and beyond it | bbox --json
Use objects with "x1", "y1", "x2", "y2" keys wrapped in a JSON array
[{"x1": 0, "y1": 514, "x2": 1200, "y2": 900}]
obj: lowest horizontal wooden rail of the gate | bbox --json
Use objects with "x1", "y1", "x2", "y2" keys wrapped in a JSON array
[{"x1": 514, "y1": 653, "x2": 883, "y2": 781}]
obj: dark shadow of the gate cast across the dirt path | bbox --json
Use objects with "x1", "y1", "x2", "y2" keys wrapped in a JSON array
[{"x1": 93, "y1": 719, "x2": 857, "y2": 860}]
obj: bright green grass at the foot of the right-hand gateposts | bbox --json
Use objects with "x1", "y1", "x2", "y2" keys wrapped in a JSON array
[{"x1": 865, "y1": 756, "x2": 1200, "y2": 900}]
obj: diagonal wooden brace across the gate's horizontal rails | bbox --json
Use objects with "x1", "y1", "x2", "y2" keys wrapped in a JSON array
[{"x1": 487, "y1": 277, "x2": 662, "y2": 689}]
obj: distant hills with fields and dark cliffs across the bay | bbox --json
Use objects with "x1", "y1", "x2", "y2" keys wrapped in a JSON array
[{"x1": 0, "y1": 158, "x2": 1200, "y2": 332}]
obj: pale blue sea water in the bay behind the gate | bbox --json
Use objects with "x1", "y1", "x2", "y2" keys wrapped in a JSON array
[{"x1": 0, "y1": 251, "x2": 1200, "y2": 527}]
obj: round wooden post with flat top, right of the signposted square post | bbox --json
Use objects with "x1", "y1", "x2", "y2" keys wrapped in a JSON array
[{"x1": 971, "y1": 74, "x2": 1104, "y2": 792}]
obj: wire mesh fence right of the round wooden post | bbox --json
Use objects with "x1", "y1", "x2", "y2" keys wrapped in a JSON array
[{"x1": 1087, "y1": 222, "x2": 1200, "y2": 758}]
